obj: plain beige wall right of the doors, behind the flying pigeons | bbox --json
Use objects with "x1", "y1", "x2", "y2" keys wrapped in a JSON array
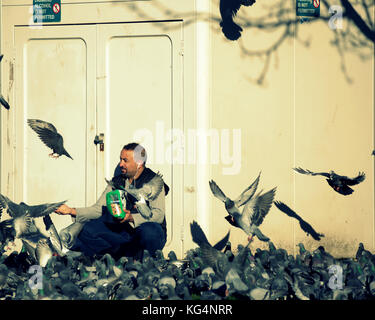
[{"x1": 211, "y1": 0, "x2": 374, "y2": 256}]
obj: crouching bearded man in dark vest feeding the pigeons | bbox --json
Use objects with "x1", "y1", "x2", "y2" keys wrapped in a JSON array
[{"x1": 55, "y1": 143, "x2": 169, "y2": 259}]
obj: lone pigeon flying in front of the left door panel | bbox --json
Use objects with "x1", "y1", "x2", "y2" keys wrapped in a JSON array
[{"x1": 27, "y1": 119, "x2": 73, "y2": 160}]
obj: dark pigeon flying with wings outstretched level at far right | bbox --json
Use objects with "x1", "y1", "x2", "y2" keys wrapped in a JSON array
[{"x1": 293, "y1": 167, "x2": 366, "y2": 196}]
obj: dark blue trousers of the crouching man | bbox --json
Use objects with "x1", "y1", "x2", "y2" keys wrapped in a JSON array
[{"x1": 70, "y1": 212, "x2": 166, "y2": 259}]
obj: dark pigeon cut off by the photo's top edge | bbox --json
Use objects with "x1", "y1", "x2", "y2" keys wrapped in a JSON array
[{"x1": 220, "y1": 0, "x2": 255, "y2": 41}]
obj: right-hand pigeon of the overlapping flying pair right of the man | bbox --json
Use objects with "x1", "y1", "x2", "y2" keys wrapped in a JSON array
[{"x1": 228, "y1": 187, "x2": 276, "y2": 245}]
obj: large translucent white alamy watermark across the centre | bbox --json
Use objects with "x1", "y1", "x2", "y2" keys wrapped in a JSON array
[{"x1": 133, "y1": 121, "x2": 242, "y2": 175}]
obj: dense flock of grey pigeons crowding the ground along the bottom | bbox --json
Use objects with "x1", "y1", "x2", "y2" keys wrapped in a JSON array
[{"x1": 0, "y1": 228, "x2": 375, "y2": 300}]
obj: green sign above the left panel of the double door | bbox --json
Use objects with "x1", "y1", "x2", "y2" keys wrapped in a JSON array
[{"x1": 33, "y1": 0, "x2": 61, "y2": 23}]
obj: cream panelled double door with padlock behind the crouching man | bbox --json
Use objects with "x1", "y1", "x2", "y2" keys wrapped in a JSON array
[{"x1": 14, "y1": 21, "x2": 184, "y2": 254}]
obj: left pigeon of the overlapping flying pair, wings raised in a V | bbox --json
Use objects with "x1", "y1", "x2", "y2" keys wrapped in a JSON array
[{"x1": 209, "y1": 172, "x2": 260, "y2": 216}]
